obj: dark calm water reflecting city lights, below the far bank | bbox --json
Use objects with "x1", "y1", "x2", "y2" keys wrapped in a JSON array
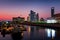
[{"x1": 0, "y1": 26, "x2": 60, "y2": 40}]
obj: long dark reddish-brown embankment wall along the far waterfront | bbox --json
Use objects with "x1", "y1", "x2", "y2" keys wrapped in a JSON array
[{"x1": 13, "y1": 21, "x2": 60, "y2": 30}]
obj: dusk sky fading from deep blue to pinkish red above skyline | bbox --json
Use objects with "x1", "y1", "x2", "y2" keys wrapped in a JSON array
[{"x1": 0, "y1": 0, "x2": 60, "y2": 20}]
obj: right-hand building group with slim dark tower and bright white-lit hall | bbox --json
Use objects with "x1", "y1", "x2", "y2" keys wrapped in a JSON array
[{"x1": 47, "y1": 7, "x2": 60, "y2": 23}]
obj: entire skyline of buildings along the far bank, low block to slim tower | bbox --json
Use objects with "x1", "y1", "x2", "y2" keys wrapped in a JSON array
[{"x1": 0, "y1": 7, "x2": 60, "y2": 25}]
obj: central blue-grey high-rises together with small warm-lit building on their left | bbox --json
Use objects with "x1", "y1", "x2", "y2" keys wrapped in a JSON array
[{"x1": 27, "y1": 10, "x2": 39, "y2": 22}]
